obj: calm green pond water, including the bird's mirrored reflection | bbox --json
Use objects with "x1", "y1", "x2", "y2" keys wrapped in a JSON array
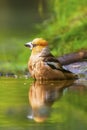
[{"x1": 0, "y1": 78, "x2": 87, "y2": 130}]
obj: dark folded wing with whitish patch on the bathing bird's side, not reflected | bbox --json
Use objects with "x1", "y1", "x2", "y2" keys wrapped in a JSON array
[{"x1": 43, "y1": 54, "x2": 71, "y2": 73}]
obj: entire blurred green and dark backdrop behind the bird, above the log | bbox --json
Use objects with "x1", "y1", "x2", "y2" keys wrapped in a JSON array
[{"x1": 0, "y1": 0, "x2": 87, "y2": 73}]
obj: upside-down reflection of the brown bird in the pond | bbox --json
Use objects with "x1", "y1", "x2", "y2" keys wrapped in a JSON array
[{"x1": 28, "y1": 80, "x2": 73, "y2": 122}]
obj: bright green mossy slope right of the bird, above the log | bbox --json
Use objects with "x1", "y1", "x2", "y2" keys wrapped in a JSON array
[{"x1": 38, "y1": 0, "x2": 87, "y2": 55}]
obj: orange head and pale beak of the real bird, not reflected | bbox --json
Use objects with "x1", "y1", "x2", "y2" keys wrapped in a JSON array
[{"x1": 25, "y1": 38, "x2": 48, "y2": 54}]
